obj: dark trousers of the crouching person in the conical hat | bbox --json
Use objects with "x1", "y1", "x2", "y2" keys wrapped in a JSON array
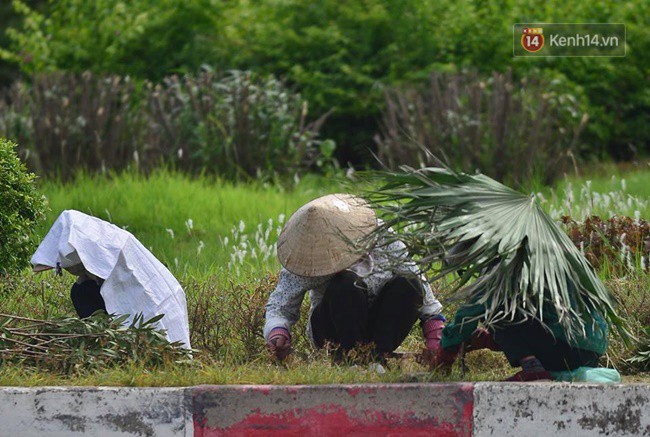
[{"x1": 310, "y1": 271, "x2": 424, "y2": 355}]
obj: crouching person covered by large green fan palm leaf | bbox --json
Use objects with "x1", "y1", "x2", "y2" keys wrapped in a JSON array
[{"x1": 371, "y1": 167, "x2": 627, "y2": 381}]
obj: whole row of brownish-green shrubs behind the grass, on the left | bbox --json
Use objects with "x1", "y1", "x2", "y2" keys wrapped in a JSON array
[{"x1": 0, "y1": 71, "x2": 333, "y2": 179}]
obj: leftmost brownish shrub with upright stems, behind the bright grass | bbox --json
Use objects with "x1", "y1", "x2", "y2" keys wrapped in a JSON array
[{"x1": 0, "y1": 73, "x2": 144, "y2": 179}]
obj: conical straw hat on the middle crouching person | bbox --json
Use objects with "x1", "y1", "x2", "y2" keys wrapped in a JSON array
[{"x1": 278, "y1": 194, "x2": 377, "y2": 276}]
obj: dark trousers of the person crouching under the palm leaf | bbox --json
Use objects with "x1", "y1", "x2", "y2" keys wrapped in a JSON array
[{"x1": 493, "y1": 320, "x2": 600, "y2": 371}]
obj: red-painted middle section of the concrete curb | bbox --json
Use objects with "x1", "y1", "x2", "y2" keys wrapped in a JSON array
[{"x1": 193, "y1": 384, "x2": 472, "y2": 437}]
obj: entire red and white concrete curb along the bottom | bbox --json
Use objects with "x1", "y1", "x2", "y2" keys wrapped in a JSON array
[{"x1": 0, "y1": 383, "x2": 650, "y2": 437}]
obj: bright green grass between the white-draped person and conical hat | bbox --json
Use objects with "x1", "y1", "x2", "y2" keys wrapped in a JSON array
[{"x1": 40, "y1": 170, "x2": 336, "y2": 276}]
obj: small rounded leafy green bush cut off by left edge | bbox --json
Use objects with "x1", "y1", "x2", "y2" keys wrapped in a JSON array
[{"x1": 0, "y1": 138, "x2": 45, "y2": 274}]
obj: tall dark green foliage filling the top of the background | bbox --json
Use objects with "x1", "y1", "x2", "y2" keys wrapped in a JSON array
[{"x1": 2, "y1": 0, "x2": 650, "y2": 160}]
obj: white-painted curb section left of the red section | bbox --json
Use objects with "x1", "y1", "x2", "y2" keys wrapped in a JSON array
[{"x1": 0, "y1": 387, "x2": 193, "y2": 437}]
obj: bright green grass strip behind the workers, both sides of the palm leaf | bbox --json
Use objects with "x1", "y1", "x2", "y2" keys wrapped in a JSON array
[{"x1": 39, "y1": 165, "x2": 650, "y2": 276}]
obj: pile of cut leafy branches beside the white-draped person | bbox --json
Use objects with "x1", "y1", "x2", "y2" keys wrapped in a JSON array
[{"x1": 0, "y1": 312, "x2": 192, "y2": 374}]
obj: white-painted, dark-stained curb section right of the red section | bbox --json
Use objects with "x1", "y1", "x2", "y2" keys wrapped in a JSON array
[{"x1": 474, "y1": 383, "x2": 650, "y2": 437}]
